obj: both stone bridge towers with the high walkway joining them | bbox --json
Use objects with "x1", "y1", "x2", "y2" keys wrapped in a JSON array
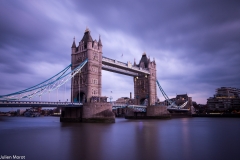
[{"x1": 71, "y1": 29, "x2": 157, "y2": 109}]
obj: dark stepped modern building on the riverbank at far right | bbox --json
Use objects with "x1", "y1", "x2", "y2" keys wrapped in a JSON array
[{"x1": 207, "y1": 87, "x2": 240, "y2": 112}]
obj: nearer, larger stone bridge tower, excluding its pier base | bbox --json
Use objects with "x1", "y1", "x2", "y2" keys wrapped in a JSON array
[{"x1": 71, "y1": 28, "x2": 102, "y2": 103}]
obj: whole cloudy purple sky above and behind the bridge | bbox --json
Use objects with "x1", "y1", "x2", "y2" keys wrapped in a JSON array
[{"x1": 0, "y1": 0, "x2": 240, "y2": 104}]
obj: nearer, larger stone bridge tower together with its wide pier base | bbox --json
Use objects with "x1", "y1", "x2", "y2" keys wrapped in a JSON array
[{"x1": 60, "y1": 28, "x2": 115, "y2": 123}]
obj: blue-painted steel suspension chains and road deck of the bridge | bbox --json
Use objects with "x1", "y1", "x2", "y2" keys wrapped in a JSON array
[{"x1": 0, "y1": 57, "x2": 186, "y2": 112}]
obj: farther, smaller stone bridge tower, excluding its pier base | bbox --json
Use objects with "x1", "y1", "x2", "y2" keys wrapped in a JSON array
[{"x1": 133, "y1": 53, "x2": 157, "y2": 106}]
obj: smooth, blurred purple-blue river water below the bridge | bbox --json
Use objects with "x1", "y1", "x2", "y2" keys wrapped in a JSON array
[{"x1": 0, "y1": 117, "x2": 240, "y2": 160}]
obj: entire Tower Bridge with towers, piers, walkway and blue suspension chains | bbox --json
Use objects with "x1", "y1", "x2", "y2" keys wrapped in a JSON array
[{"x1": 0, "y1": 29, "x2": 192, "y2": 122}]
